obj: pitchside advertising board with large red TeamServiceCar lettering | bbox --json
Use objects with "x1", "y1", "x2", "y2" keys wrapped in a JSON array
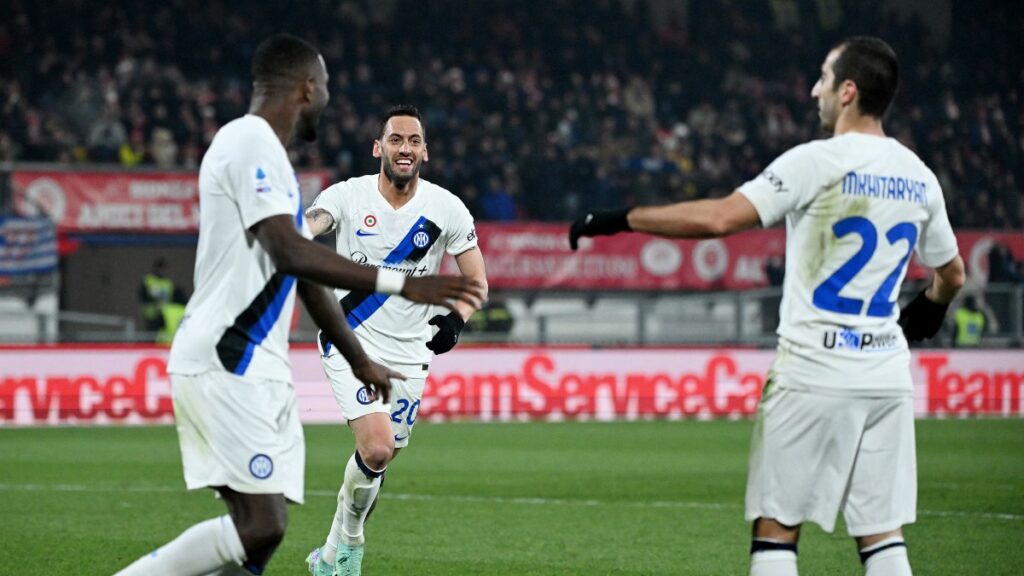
[{"x1": 0, "y1": 346, "x2": 1024, "y2": 426}]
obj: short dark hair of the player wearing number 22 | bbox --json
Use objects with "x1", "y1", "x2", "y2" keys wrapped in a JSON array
[{"x1": 833, "y1": 36, "x2": 899, "y2": 119}]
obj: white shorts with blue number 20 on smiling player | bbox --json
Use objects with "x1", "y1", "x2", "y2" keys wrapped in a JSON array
[{"x1": 322, "y1": 354, "x2": 429, "y2": 448}]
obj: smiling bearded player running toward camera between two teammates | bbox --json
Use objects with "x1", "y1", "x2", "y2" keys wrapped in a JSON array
[{"x1": 306, "y1": 106, "x2": 486, "y2": 576}]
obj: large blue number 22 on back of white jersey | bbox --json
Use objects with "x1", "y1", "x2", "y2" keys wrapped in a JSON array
[{"x1": 814, "y1": 216, "x2": 918, "y2": 318}]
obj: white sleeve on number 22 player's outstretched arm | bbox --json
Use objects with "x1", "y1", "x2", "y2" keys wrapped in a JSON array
[{"x1": 738, "y1": 145, "x2": 819, "y2": 228}]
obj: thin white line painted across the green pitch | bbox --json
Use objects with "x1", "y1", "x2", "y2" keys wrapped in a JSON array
[{"x1": 0, "y1": 484, "x2": 1024, "y2": 522}]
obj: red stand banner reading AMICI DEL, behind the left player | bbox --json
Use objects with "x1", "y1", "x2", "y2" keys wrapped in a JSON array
[{"x1": 11, "y1": 170, "x2": 328, "y2": 234}]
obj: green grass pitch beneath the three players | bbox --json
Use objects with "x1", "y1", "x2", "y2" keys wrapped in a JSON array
[{"x1": 0, "y1": 419, "x2": 1024, "y2": 576}]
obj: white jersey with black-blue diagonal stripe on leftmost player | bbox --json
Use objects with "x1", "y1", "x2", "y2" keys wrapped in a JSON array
[{"x1": 167, "y1": 115, "x2": 309, "y2": 381}]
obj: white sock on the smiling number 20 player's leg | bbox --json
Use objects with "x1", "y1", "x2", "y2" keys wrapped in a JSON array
[{"x1": 321, "y1": 452, "x2": 384, "y2": 562}]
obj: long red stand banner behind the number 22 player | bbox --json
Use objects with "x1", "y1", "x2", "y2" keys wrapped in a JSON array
[{"x1": 444, "y1": 222, "x2": 1024, "y2": 290}]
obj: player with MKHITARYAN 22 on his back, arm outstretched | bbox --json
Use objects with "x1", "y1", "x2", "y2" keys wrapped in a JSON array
[{"x1": 569, "y1": 37, "x2": 964, "y2": 576}]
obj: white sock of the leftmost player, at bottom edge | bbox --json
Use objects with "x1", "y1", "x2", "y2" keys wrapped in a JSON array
[{"x1": 115, "y1": 516, "x2": 246, "y2": 576}]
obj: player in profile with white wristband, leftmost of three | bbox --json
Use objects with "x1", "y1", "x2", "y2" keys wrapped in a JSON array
[{"x1": 114, "y1": 35, "x2": 483, "y2": 576}]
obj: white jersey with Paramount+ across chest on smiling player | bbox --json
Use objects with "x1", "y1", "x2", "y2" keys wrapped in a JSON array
[{"x1": 309, "y1": 174, "x2": 476, "y2": 364}]
